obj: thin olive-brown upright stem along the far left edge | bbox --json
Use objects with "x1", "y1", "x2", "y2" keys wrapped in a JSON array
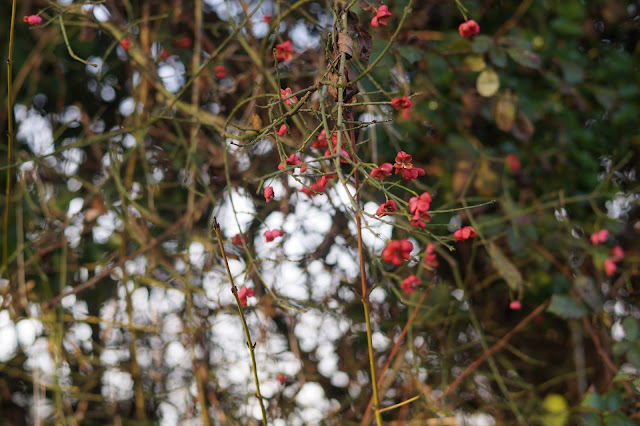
[{"x1": 2, "y1": 0, "x2": 16, "y2": 274}]
